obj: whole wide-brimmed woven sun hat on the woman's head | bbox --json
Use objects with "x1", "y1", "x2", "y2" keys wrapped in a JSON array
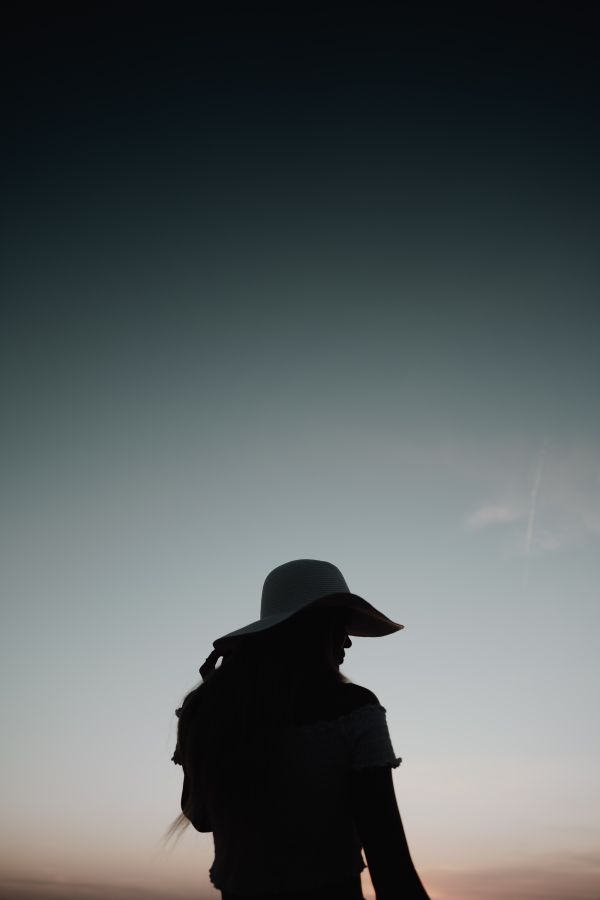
[{"x1": 211, "y1": 559, "x2": 404, "y2": 656}]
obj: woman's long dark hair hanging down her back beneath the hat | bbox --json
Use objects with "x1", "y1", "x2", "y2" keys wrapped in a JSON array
[{"x1": 167, "y1": 606, "x2": 350, "y2": 838}]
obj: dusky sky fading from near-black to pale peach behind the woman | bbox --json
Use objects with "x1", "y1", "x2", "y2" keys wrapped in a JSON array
[{"x1": 0, "y1": 4, "x2": 600, "y2": 900}]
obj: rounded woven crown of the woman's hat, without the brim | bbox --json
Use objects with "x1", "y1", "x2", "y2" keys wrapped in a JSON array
[{"x1": 260, "y1": 559, "x2": 350, "y2": 619}]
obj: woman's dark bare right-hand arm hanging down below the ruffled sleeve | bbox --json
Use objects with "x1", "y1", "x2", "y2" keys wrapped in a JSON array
[{"x1": 351, "y1": 766, "x2": 429, "y2": 900}]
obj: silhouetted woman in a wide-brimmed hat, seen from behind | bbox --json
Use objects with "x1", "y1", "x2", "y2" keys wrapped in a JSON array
[{"x1": 172, "y1": 559, "x2": 428, "y2": 900}]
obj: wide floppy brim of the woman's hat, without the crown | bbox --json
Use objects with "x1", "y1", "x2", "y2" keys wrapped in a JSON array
[{"x1": 213, "y1": 593, "x2": 404, "y2": 652}]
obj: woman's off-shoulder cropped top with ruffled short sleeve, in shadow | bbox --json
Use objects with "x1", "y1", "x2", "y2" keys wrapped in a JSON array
[{"x1": 204, "y1": 686, "x2": 401, "y2": 895}]
